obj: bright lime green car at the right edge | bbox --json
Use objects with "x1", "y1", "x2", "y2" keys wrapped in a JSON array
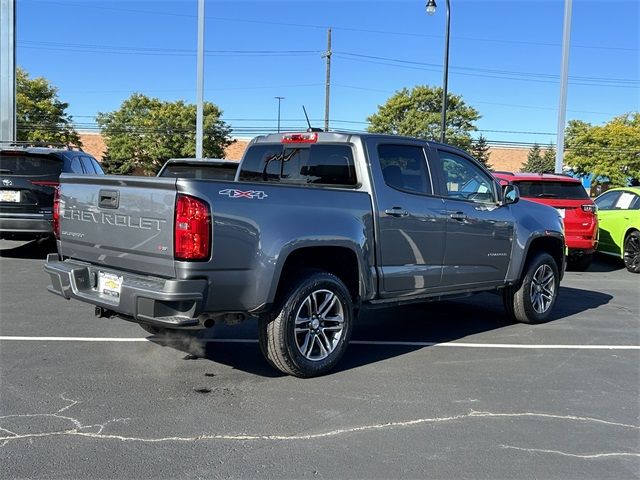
[{"x1": 595, "y1": 187, "x2": 640, "y2": 273}]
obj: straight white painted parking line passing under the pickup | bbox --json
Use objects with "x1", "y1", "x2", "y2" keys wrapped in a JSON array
[{"x1": 0, "y1": 336, "x2": 640, "y2": 350}]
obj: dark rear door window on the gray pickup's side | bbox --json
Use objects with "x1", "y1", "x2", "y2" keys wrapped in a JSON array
[{"x1": 378, "y1": 145, "x2": 433, "y2": 195}]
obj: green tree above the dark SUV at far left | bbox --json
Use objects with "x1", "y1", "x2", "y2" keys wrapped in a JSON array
[{"x1": 16, "y1": 67, "x2": 82, "y2": 146}]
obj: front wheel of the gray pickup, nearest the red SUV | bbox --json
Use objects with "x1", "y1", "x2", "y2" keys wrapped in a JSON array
[{"x1": 502, "y1": 253, "x2": 560, "y2": 324}]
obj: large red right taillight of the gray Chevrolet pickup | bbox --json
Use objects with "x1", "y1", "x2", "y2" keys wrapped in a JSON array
[{"x1": 173, "y1": 194, "x2": 211, "y2": 260}]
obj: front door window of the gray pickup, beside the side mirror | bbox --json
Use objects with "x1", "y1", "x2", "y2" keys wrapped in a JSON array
[{"x1": 438, "y1": 150, "x2": 497, "y2": 203}]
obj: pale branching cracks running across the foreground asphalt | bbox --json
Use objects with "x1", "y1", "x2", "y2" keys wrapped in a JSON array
[{"x1": 0, "y1": 394, "x2": 640, "y2": 459}]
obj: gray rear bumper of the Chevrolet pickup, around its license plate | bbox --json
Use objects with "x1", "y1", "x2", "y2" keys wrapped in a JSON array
[{"x1": 44, "y1": 253, "x2": 208, "y2": 328}]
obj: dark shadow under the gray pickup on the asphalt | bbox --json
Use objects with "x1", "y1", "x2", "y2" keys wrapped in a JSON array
[{"x1": 150, "y1": 287, "x2": 613, "y2": 377}]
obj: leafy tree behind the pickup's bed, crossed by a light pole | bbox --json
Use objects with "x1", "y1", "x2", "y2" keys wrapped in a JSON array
[{"x1": 97, "y1": 93, "x2": 233, "y2": 175}]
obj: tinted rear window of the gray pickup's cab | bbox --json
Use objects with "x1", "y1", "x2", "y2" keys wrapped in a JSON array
[{"x1": 239, "y1": 144, "x2": 357, "y2": 186}]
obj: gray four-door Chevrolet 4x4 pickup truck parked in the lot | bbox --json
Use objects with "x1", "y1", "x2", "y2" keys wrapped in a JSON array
[{"x1": 45, "y1": 132, "x2": 565, "y2": 377}]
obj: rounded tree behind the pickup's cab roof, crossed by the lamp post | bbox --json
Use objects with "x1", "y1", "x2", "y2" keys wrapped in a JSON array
[{"x1": 367, "y1": 85, "x2": 480, "y2": 150}]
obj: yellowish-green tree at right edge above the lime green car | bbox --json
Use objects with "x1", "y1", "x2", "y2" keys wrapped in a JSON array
[{"x1": 565, "y1": 112, "x2": 640, "y2": 186}]
